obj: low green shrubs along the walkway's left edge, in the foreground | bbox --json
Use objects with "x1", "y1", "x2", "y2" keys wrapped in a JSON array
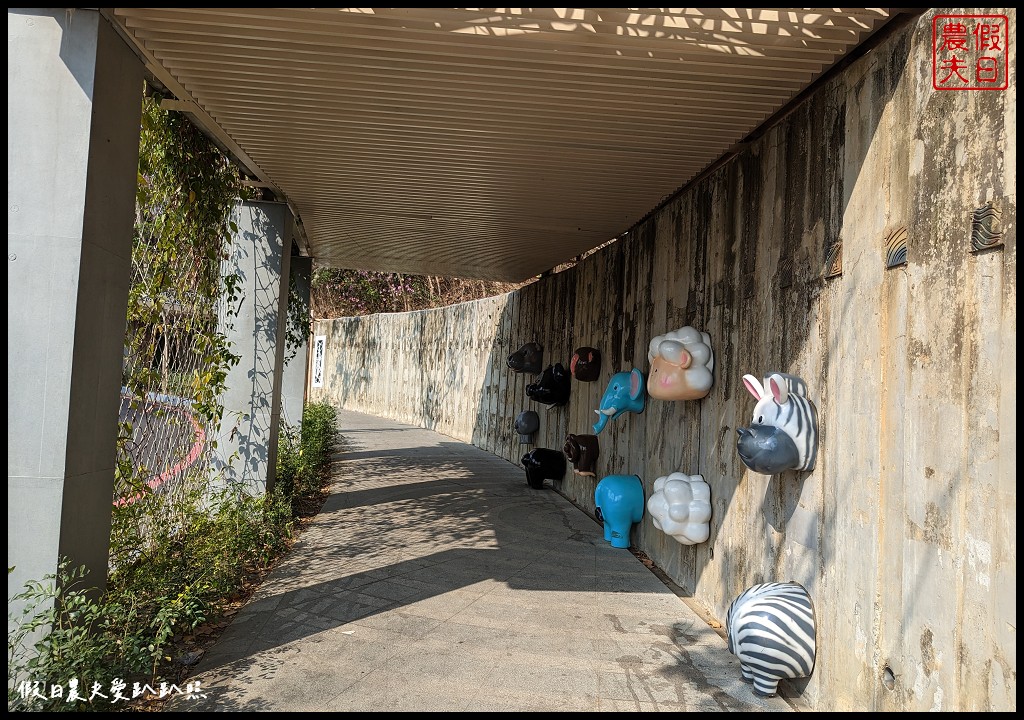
[{"x1": 7, "y1": 478, "x2": 293, "y2": 711}]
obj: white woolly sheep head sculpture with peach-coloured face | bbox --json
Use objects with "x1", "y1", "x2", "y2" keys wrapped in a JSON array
[{"x1": 647, "y1": 325, "x2": 715, "y2": 400}]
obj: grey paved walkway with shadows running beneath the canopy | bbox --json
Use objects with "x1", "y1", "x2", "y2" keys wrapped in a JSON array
[{"x1": 178, "y1": 412, "x2": 795, "y2": 712}]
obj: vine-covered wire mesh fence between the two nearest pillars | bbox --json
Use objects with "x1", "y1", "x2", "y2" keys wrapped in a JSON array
[{"x1": 115, "y1": 98, "x2": 242, "y2": 507}]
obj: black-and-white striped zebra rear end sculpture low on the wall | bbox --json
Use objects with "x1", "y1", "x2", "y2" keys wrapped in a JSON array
[{"x1": 725, "y1": 582, "x2": 815, "y2": 697}]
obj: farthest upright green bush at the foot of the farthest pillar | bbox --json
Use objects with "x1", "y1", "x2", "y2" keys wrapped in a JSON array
[{"x1": 276, "y1": 403, "x2": 338, "y2": 514}]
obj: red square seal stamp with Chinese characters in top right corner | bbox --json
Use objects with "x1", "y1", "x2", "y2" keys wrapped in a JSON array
[{"x1": 932, "y1": 15, "x2": 1010, "y2": 90}]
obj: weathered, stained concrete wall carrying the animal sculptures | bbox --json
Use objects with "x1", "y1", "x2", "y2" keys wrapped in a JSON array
[{"x1": 310, "y1": 9, "x2": 1017, "y2": 711}]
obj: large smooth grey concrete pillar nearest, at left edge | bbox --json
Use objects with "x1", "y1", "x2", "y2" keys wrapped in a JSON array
[{"x1": 7, "y1": 8, "x2": 142, "y2": 598}]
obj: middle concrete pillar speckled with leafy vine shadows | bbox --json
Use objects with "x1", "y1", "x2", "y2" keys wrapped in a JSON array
[{"x1": 217, "y1": 202, "x2": 292, "y2": 494}]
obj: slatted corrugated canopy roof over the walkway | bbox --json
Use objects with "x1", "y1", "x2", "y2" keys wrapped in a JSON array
[{"x1": 113, "y1": 8, "x2": 890, "y2": 281}]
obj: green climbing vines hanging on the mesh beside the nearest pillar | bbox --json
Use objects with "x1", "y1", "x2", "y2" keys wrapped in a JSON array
[{"x1": 123, "y1": 90, "x2": 245, "y2": 438}]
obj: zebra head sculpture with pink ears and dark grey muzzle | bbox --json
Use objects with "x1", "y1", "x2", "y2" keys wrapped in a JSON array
[{"x1": 736, "y1": 373, "x2": 818, "y2": 475}]
